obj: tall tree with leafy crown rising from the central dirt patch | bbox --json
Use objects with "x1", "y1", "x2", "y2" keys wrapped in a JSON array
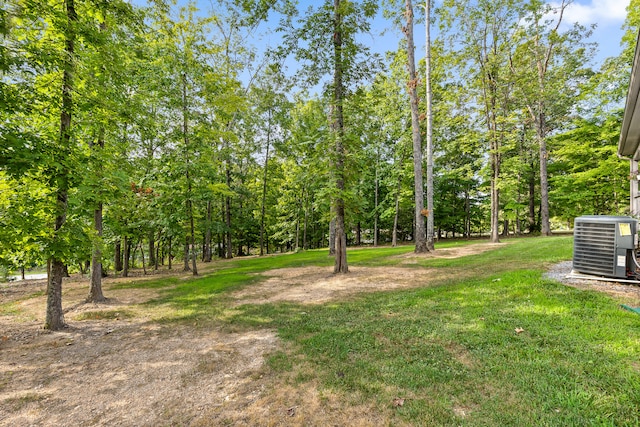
[{"x1": 286, "y1": 0, "x2": 377, "y2": 273}]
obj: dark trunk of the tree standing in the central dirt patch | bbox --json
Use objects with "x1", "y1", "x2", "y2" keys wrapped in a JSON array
[{"x1": 332, "y1": 0, "x2": 349, "y2": 274}]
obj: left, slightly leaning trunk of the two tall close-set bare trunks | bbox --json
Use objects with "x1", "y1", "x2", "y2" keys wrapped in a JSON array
[{"x1": 404, "y1": 0, "x2": 429, "y2": 253}]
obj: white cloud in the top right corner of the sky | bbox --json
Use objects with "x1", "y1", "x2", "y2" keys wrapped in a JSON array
[{"x1": 550, "y1": 0, "x2": 630, "y2": 25}]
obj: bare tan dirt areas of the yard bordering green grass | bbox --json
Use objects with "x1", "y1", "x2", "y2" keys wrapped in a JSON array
[{"x1": 7, "y1": 244, "x2": 624, "y2": 426}]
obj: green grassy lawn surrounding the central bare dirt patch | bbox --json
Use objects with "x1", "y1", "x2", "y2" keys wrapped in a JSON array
[{"x1": 117, "y1": 237, "x2": 640, "y2": 426}]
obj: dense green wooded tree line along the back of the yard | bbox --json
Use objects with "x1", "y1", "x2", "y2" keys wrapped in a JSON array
[{"x1": 0, "y1": 0, "x2": 640, "y2": 329}]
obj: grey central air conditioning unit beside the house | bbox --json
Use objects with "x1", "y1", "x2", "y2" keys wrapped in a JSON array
[{"x1": 573, "y1": 215, "x2": 638, "y2": 279}]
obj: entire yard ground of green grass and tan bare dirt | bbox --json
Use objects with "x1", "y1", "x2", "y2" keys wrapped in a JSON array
[{"x1": 0, "y1": 236, "x2": 640, "y2": 426}]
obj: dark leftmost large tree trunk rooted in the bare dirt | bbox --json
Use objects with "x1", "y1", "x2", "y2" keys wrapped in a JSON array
[{"x1": 44, "y1": 0, "x2": 78, "y2": 331}]
